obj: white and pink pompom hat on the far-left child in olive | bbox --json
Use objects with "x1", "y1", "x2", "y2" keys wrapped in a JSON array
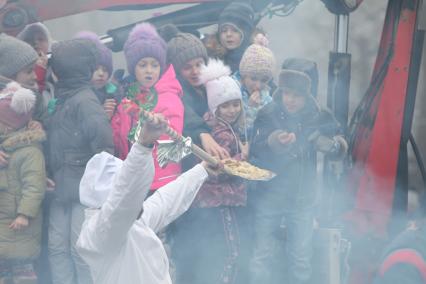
[{"x1": 0, "y1": 82, "x2": 36, "y2": 129}]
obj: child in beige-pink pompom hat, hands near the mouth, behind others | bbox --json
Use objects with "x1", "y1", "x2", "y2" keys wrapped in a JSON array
[{"x1": 234, "y1": 34, "x2": 275, "y2": 139}]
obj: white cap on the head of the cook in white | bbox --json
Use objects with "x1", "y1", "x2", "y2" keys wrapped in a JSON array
[{"x1": 80, "y1": 152, "x2": 123, "y2": 208}]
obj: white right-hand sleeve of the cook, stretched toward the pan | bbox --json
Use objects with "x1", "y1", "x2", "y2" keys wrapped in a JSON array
[{"x1": 142, "y1": 165, "x2": 208, "y2": 232}]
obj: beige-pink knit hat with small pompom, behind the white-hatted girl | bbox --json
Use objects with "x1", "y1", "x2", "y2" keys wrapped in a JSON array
[{"x1": 240, "y1": 34, "x2": 275, "y2": 79}]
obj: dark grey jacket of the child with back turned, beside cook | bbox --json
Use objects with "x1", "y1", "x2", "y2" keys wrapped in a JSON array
[{"x1": 47, "y1": 85, "x2": 114, "y2": 203}]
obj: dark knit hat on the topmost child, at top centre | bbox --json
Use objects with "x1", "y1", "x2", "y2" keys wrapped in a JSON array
[{"x1": 219, "y1": 2, "x2": 255, "y2": 41}]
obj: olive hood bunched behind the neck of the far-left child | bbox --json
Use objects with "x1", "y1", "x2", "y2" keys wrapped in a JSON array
[{"x1": 0, "y1": 129, "x2": 46, "y2": 152}]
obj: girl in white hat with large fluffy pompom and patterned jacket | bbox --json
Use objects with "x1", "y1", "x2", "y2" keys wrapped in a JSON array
[{"x1": 175, "y1": 59, "x2": 247, "y2": 284}]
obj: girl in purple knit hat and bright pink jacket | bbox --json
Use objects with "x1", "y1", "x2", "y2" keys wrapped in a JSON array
[{"x1": 111, "y1": 23, "x2": 184, "y2": 190}]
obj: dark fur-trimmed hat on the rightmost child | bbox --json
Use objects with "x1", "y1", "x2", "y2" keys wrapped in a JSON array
[{"x1": 274, "y1": 69, "x2": 311, "y2": 97}]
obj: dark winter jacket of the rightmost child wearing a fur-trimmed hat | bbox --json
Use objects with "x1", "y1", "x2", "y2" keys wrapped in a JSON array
[{"x1": 250, "y1": 97, "x2": 340, "y2": 212}]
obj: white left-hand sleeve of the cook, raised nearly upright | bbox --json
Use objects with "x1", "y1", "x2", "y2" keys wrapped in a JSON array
[{"x1": 77, "y1": 143, "x2": 154, "y2": 255}]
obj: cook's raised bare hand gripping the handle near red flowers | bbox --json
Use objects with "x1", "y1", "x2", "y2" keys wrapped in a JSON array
[{"x1": 138, "y1": 113, "x2": 168, "y2": 147}]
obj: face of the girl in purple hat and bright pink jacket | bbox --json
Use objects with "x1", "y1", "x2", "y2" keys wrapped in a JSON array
[{"x1": 135, "y1": 57, "x2": 161, "y2": 89}]
